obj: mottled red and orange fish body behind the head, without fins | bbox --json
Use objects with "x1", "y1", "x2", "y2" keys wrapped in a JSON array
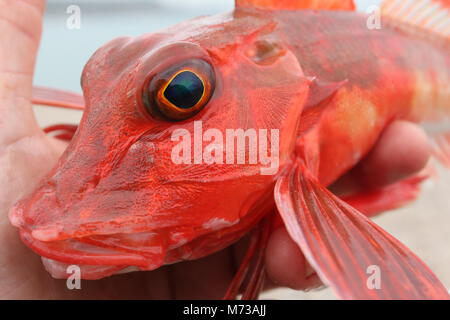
[{"x1": 273, "y1": 10, "x2": 450, "y2": 185}]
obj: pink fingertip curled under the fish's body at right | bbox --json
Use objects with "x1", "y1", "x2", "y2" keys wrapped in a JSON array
[{"x1": 331, "y1": 121, "x2": 431, "y2": 194}]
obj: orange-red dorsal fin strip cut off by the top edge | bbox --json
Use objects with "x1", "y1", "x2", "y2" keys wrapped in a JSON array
[{"x1": 236, "y1": 0, "x2": 355, "y2": 11}]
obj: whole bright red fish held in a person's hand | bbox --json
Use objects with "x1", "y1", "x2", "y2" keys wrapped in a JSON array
[{"x1": 10, "y1": 0, "x2": 450, "y2": 299}]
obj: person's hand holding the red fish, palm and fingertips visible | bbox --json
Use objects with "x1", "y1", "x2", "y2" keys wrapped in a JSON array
[{"x1": 0, "y1": 0, "x2": 430, "y2": 299}]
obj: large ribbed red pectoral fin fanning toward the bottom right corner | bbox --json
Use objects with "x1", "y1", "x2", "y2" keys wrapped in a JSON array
[{"x1": 275, "y1": 163, "x2": 450, "y2": 299}]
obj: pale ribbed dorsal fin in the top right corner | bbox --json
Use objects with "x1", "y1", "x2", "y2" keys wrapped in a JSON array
[{"x1": 381, "y1": 0, "x2": 450, "y2": 40}]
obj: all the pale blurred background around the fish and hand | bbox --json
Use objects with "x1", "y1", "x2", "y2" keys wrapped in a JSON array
[{"x1": 34, "y1": 0, "x2": 450, "y2": 299}]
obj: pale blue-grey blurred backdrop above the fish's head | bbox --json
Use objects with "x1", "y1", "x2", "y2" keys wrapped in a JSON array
[{"x1": 35, "y1": 0, "x2": 380, "y2": 92}]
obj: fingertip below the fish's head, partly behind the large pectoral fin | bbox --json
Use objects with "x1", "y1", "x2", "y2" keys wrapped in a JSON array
[{"x1": 266, "y1": 227, "x2": 321, "y2": 290}]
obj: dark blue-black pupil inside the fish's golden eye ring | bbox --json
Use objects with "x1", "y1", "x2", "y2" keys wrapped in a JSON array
[{"x1": 164, "y1": 71, "x2": 205, "y2": 109}]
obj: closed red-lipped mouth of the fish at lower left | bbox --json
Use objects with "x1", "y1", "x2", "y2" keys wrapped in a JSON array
[{"x1": 9, "y1": 206, "x2": 166, "y2": 280}]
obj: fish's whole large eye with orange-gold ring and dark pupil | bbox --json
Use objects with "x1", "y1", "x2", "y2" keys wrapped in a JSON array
[{"x1": 143, "y1": 59, "x2": 215, "y2": 121}]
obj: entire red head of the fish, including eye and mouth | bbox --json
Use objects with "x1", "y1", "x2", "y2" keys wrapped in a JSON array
[{"x1": 10, "y1": 10, "x2": 309, "y2": 278}]
